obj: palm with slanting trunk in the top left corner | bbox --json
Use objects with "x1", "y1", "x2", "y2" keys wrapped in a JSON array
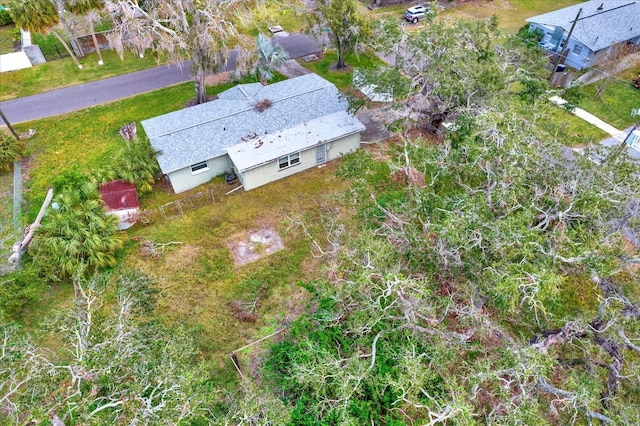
[{"x1": 9, "y1": 0, "x2": 82, "y2": 69}]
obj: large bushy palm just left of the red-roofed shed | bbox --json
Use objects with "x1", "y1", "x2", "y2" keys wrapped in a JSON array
[{"x1": 32, "y1": 182, "x2": 122, "y2": 277}]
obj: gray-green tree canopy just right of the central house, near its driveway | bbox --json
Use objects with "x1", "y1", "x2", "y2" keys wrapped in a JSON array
[{"x1": 368, "y1": 17, "x2": 547, "y2": 130}]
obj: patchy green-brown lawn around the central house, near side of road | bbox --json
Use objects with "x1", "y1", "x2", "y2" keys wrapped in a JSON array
[{"x1": 13, "y1": 74, "x2": 356, "y2": 384}]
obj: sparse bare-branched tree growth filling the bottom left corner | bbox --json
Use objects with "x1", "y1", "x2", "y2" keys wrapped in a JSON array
[{"x1": 0, "y1": 272, "x2": 212, "y2": 424}]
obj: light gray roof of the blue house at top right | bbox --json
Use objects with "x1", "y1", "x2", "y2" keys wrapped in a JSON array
[{"x1": 526, "y1": 0, "x2": 640, "y2": 52}]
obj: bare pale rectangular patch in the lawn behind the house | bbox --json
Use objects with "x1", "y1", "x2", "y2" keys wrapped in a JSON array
[{"x1": 227, "y1": 226, "x2": 284, "y2": 266}]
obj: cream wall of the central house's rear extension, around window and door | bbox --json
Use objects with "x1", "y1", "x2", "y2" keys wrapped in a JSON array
[{"x1": 237, "y1": 133, "x2": 360, "y2": 191}]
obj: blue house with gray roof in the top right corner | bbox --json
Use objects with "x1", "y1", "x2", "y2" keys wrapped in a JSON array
[{"x1": 526, "y1": 0, "x2": 640, "y2": 70}]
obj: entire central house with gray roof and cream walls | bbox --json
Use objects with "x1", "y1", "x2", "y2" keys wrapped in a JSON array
[{"x1": 142, "y1": 74, "x2": 364, "y2": 193}]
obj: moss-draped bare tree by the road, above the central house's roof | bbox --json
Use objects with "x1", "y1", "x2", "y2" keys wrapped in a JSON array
[{"x1": 105, "y1": 0, "x2": 252, "y2": 103}]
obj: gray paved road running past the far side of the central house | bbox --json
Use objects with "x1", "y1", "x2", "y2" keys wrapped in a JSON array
[{"x1": 0, "y1": 34, "x2": 322, "y2": 124}]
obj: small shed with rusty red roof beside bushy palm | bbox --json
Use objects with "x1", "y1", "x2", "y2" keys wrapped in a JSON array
[{"x1": 99, "y1": 180, "x2": 140, "y2": 230}]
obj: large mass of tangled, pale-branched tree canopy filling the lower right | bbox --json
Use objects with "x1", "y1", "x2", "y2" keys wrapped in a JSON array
[{"x1": 267, "y1": 101, "x2": 640, "y2": 424}]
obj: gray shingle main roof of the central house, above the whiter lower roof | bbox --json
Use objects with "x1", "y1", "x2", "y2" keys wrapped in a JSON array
[{"x1": 142, "y1": 74, "x2": 347, "y2": 174}]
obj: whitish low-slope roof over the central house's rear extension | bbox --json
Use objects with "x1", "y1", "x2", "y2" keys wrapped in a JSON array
[{"x1": 227, "y1": 111, "x2": 364, "y2": 172}]
